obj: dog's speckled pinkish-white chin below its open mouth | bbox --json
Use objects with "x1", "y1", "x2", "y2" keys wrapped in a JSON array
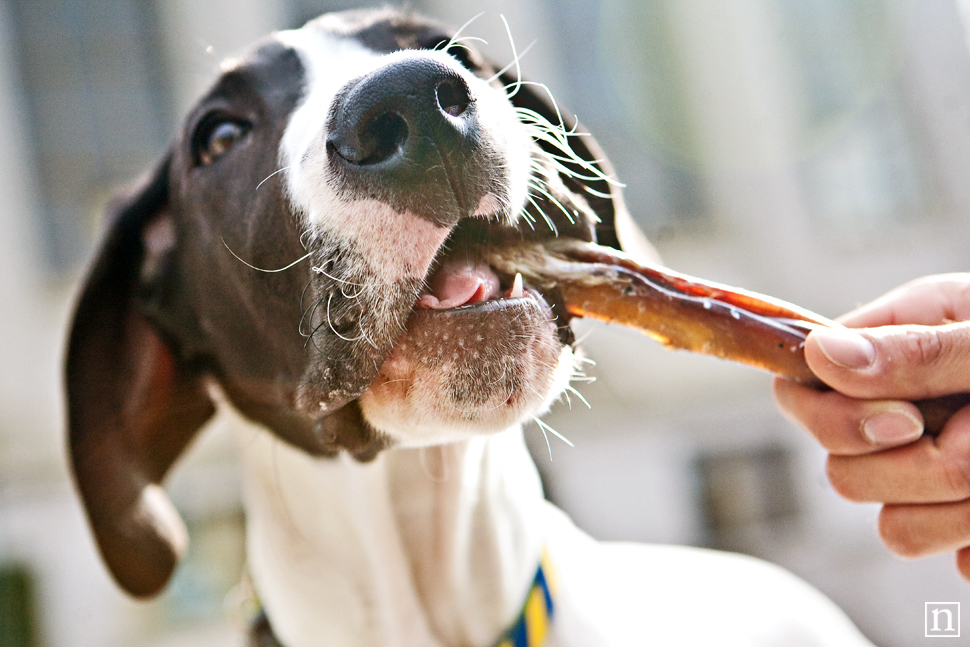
[{"x1": 360, "y1": 290, "x2": 574, "y2": 447}]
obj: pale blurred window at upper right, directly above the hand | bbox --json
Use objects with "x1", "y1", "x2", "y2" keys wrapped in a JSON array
[{"x1": 774, "y1": 0, "x2": 924, "y2": 234}]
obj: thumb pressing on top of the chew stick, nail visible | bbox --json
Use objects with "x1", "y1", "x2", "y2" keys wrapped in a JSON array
[{"x1": 805, "y1": 322, "x2": 970, "y2": 400}]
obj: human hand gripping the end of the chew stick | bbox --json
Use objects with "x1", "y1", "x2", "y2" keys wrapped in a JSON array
[{"x1": 774, "y1": 273, "x2": 970, "y2": 580}]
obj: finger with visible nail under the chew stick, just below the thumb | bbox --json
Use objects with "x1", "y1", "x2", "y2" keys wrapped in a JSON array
[{"x1": 773, "y1": 378, "x2": 923, "y2": 456}]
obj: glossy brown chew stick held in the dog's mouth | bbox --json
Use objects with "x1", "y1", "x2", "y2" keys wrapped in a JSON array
[{"x1": 491, "y1": 239, "x2": 970, "y2": 435}]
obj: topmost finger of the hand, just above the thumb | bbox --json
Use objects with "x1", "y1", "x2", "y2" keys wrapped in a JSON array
[{"x1": 838, "y1": 272, "x2": 970, "y2": 328}]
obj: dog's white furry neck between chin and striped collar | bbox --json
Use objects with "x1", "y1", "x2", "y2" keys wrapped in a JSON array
[{"x1": 233, "y1": 408, "x2": 545, "y2": 647}]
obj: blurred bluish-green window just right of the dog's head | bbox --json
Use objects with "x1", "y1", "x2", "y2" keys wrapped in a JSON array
[{"x1": 538, "y1": 0, "x2": 708, "y2": 234}]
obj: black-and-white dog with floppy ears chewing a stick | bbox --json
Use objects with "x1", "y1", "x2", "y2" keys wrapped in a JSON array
[{"x1": 66, "y1": 9, "x2": 868, "y2": 647}]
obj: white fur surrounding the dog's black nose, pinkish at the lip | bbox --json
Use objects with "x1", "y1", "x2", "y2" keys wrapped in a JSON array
[{"x1": 277, "y1": 25, "x2": 532, "y2": 284}]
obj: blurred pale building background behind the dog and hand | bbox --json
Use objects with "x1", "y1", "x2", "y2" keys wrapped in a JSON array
[{"x1": 0, "y1": 0, "x2": 970, "y2": 647}]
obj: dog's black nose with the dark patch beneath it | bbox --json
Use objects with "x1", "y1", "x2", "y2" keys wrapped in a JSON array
[{"x1": 327, "y1": 52, "x2": 497, "y2": 225}]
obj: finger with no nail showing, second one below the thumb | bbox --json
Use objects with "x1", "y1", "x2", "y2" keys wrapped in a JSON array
[{"x1": 826, "y1": 407, "x2": 970, "y2": 504}]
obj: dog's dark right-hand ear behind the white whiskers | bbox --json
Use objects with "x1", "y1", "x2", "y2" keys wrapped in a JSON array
[{"x1": 499, "y1": 72, "x2": 659, "y2": 262}]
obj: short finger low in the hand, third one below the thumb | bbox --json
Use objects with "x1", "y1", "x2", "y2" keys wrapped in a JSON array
[{"x1": 879, "y1": 500, "x2": 970, "y2": 558}]
